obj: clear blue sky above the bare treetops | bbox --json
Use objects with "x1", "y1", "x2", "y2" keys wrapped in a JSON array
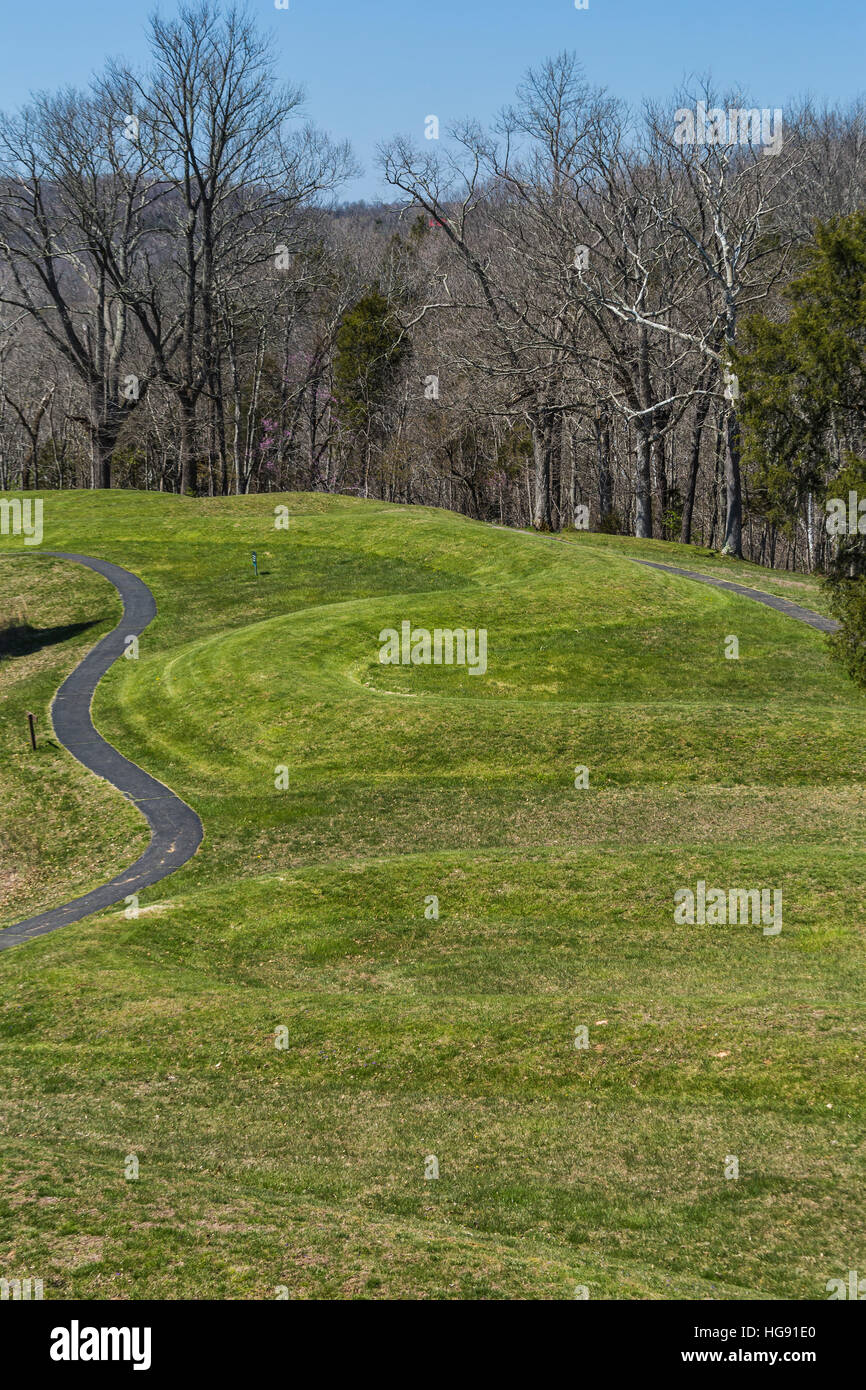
[{"x1": 0, "y1": 0, "x2": 866, "y2": 199}]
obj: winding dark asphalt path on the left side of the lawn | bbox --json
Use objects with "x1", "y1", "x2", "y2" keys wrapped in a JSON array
[{"x1": 0, "y1": 550, "x2": 204, "y2": 951}]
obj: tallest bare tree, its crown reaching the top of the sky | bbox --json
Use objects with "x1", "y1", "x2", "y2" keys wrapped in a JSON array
[{"x1": 115, "y1": 0, "x2": 353, "y2": 492}]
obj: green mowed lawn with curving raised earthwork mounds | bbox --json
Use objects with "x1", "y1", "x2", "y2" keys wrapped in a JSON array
[{"x1": 0, "y1": 492, "x2": 866, "y2": 1300}]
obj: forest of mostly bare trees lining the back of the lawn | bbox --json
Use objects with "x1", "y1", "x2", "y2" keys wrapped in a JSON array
[{"x1": 0, "y1": 3, "x2": 866, "y2": 570}]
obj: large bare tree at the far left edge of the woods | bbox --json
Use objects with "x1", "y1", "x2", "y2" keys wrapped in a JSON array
[{"x1": 0, "y1": 86, "x2": 165, "y2": 487}]
